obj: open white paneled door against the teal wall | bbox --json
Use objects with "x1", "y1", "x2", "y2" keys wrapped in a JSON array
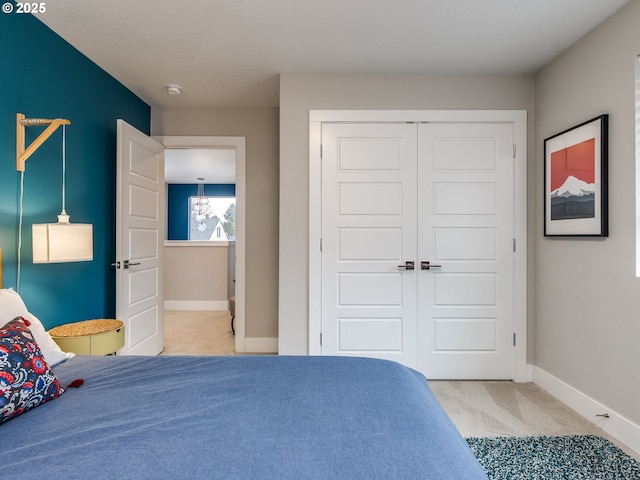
[{"x1": 116, "y1": 120, "x2": 164, "y2": 355}]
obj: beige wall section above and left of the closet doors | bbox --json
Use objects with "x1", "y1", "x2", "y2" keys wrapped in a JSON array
[{"x1": 279, "y1": 75, "x2": 534, "y2": 355}]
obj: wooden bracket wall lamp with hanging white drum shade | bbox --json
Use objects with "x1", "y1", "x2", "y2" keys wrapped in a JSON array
[{"x1": 16, "y1": 113, "x2": 93, "y2": 266}]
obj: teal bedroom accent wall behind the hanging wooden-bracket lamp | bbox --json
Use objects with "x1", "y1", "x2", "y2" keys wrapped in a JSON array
[{"x1": 0, "y1": 9, "x2": 151, "y2": 328}]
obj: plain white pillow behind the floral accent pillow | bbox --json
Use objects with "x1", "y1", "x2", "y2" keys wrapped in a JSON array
[{"x1": 0, "y1": 288, "x2": 75, "y2": 367}]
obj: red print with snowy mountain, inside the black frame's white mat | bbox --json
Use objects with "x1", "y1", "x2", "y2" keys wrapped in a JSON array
[{"x1": 549, "y1": 138, "x2": 596, "y2": 220}]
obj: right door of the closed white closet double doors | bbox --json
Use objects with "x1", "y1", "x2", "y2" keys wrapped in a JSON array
[{"x1": 418, "y1": 124, "x2": 514, "y2": 379}]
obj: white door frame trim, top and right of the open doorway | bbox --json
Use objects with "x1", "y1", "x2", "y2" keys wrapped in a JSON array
[{"x1": 155, "y1": 136, "x2": 246, "y2": 353}]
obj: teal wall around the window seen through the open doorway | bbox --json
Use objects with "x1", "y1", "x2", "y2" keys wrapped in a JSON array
[{"x1": 167, "y1": 183, "x2": 236, "y2": 240}]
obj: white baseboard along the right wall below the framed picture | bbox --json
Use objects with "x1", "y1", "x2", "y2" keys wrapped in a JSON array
[{"x1": 532, "y1": 366, "x2": 640, "y2": 453}]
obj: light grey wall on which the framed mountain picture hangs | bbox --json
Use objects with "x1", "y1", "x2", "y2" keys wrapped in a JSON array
[{"x1": 532, "y1": 0, "x2": 640, "y2": 428}]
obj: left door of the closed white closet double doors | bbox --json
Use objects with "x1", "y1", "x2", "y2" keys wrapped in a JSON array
[{"x1": 321, "y1": 124, "x2": 417, "y2": 368}]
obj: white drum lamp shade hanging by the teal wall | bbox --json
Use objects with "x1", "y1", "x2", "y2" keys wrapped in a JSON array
[{"x1": 32, "y1": 222, "x2": 93, "y2": 263}]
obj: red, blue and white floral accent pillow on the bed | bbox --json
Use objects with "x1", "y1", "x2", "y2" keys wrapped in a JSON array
[{"x1": 0, "y1": 317, "x2": 64, "y2": 424}]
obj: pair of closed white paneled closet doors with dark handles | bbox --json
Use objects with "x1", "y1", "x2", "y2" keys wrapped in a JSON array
[{"x1": 321, "y1": 123, "x2": 514, "y2": 379}]
